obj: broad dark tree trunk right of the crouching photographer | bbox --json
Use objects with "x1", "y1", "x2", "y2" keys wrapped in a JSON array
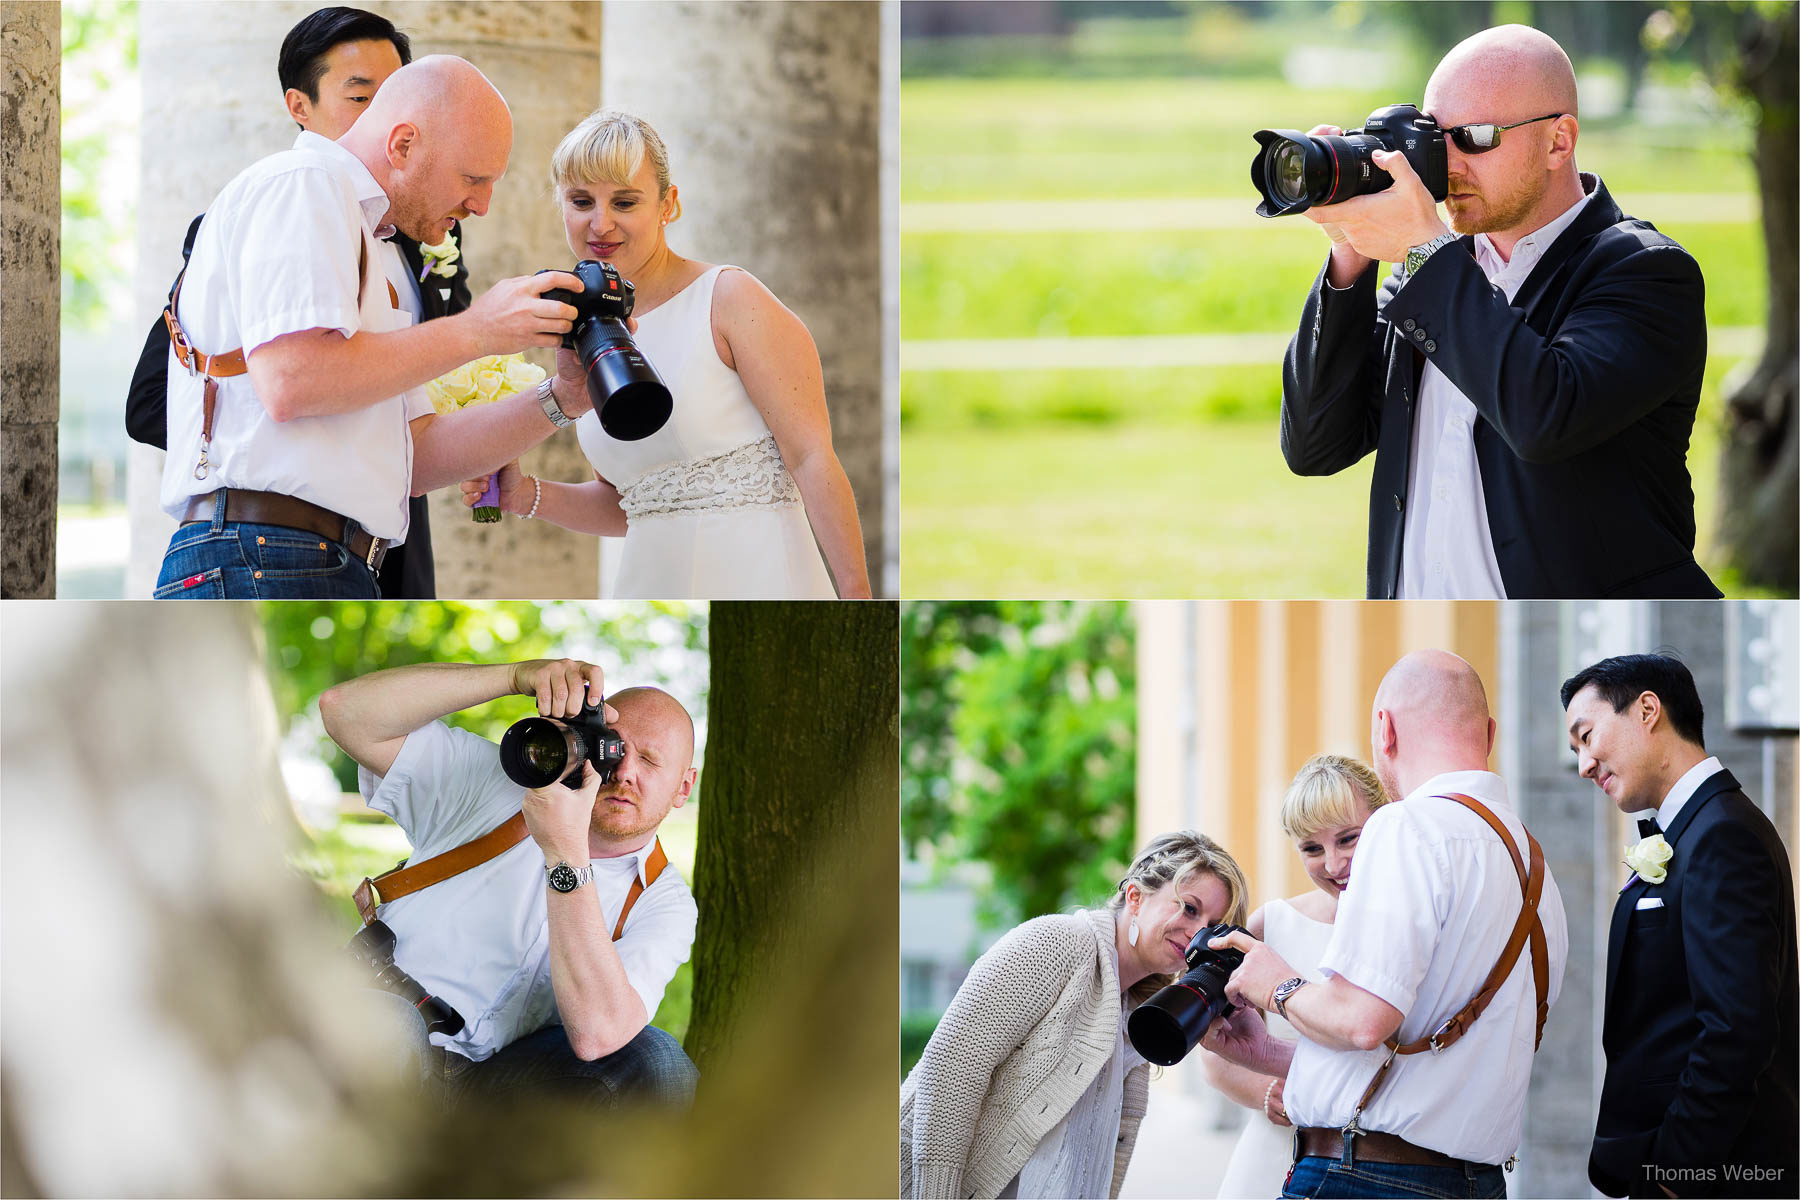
[{"x1": 688, "y1": 601, "x2": 900, "y2": 1195}]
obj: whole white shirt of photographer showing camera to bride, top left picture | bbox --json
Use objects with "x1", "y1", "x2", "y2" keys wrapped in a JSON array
[{"x1": 160, "y1": 133, "x2": 432, "y2": 542}]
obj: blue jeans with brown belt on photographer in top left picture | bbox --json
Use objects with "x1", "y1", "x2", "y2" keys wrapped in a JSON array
[{"x1": 155, "y1": 488, "x2": 382, "y2": 599}]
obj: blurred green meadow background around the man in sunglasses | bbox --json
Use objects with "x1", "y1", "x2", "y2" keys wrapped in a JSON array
[{"x1": 900, "y1": 2, "x2": 1768, "y2": 597}]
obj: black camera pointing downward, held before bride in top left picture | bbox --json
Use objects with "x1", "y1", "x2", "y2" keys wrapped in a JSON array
[{"x1": 538, "y1": 263, "x2": 675, "y2": 441}]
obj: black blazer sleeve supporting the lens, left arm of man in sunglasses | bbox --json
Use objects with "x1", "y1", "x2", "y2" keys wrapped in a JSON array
[{"x1": 1282, "y1": 257, "x2": 1391, "y2": 475}]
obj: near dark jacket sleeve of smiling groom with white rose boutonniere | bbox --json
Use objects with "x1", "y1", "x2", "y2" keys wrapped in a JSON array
[{"x1": 1651, "y1": 822, "x2": 1793, "y2": 1191}]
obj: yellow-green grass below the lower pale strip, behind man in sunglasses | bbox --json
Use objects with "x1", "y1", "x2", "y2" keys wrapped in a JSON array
[{"x1": 900, "y1": 358, "x2": 1735, "y2": 599}]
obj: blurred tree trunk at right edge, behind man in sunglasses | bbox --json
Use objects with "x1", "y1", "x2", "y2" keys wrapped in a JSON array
[{"x1": 1717, "y1": 5, "x2": 1800, "y2": 596}]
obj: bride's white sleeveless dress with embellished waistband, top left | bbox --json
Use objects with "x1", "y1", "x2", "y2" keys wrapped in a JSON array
[{"x1": 576, "y1": 266, "x2": 837, "y2": 599}]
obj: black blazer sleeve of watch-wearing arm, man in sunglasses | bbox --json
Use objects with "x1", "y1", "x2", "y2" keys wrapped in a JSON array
[{"x1": 1384, "y1": 227, "x2": 1706, "y2": 462}]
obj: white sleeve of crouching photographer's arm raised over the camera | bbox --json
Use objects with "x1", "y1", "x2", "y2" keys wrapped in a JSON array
[{"x1": 356, "y1": 721, "x2": 518, "y2": 852}]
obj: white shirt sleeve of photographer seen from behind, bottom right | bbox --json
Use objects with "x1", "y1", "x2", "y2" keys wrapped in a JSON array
[{"x1": 1319, "y1": 804, "x2": 1447, "y2": 1013}]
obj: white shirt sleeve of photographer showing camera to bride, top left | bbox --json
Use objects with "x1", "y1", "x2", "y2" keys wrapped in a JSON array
[{"x1": 225, "y1": 166, "x2": 362, "y2": 354}]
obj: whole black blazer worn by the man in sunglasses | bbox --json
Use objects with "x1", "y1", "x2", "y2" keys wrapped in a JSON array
[{"x1": 1282, "y1": 175, "x2": 1719, "y2": 599}]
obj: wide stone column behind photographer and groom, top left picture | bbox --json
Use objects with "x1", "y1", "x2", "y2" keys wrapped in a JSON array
[{"x1": 126, "y1": 0, "x2": 599, "y2": 599}]
